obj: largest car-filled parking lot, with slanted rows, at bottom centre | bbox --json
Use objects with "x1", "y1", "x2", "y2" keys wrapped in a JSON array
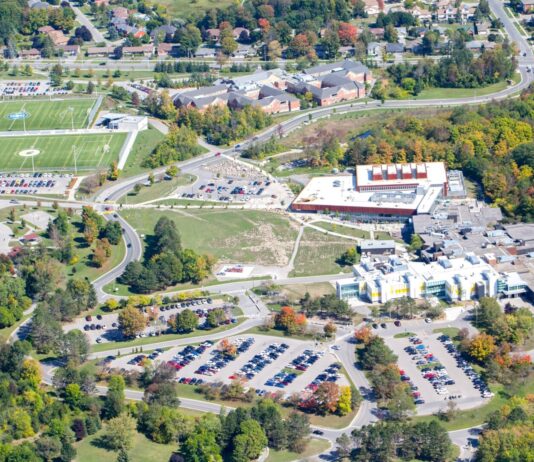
[{"x1": 108, "y1": 335, "x2": 349, "y2": 396}]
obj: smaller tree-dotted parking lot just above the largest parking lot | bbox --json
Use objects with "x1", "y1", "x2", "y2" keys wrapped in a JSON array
[{"x1": 64, "y1": 299, "x2": 232, "y2": 343}]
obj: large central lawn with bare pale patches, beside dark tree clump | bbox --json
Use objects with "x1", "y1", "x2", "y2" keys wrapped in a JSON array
[{"x1": 121, "y1": 209, "x2": 297, "y2": 265}]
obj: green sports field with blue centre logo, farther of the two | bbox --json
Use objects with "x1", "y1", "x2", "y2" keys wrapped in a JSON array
[{"x1": 0, "y1": 98, "x2": 96, "y2": 131}]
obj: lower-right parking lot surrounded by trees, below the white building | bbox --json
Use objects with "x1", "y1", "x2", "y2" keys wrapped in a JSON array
[{"x1": 385, "y1": 334, "x2": 481, "y2": 408}]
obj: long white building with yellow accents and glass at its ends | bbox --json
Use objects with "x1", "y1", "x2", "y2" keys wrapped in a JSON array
[{"x1": 337, "y1": 254, "x2": 526, "y2": 303}]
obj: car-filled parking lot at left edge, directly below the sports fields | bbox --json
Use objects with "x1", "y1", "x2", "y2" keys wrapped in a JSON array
[{"x1": 0, "y1": 173, "x2": 75, "y2": 195}]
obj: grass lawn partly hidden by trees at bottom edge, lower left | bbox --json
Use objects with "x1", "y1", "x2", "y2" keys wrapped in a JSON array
[{"x1": 75, "y1": 430, "x2": 178, "y2": 462}]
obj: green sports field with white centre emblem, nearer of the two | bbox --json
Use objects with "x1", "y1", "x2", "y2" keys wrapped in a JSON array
[{"x1": 0, "y1": 133, "x2": 127, "y2": 172}]
